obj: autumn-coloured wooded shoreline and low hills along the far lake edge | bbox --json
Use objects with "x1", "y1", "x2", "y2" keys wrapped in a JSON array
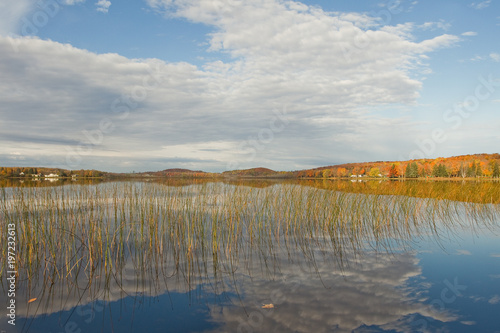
[{"x1": 0, "y1": 154, "x2": 500, "y2": 179}]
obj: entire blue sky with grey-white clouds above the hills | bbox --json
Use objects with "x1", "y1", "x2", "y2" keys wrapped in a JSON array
[{"x1": 0, "y1": 0, "x2": 500, "y2": 171}]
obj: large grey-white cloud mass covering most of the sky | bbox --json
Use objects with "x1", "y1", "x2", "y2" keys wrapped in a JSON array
[{"x1": 0, "y1": 0, "x2": 458, "y2": 171}]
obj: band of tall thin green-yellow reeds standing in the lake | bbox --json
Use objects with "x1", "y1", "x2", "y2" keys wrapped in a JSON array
[{"x1": 0, "y1": 182, "x2": 500, "y2": 312}]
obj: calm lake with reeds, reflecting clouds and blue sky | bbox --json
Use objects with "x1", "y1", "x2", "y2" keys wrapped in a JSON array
[{"x1": 0, "y1": 180, "x2": 500, "y2": 333}]
